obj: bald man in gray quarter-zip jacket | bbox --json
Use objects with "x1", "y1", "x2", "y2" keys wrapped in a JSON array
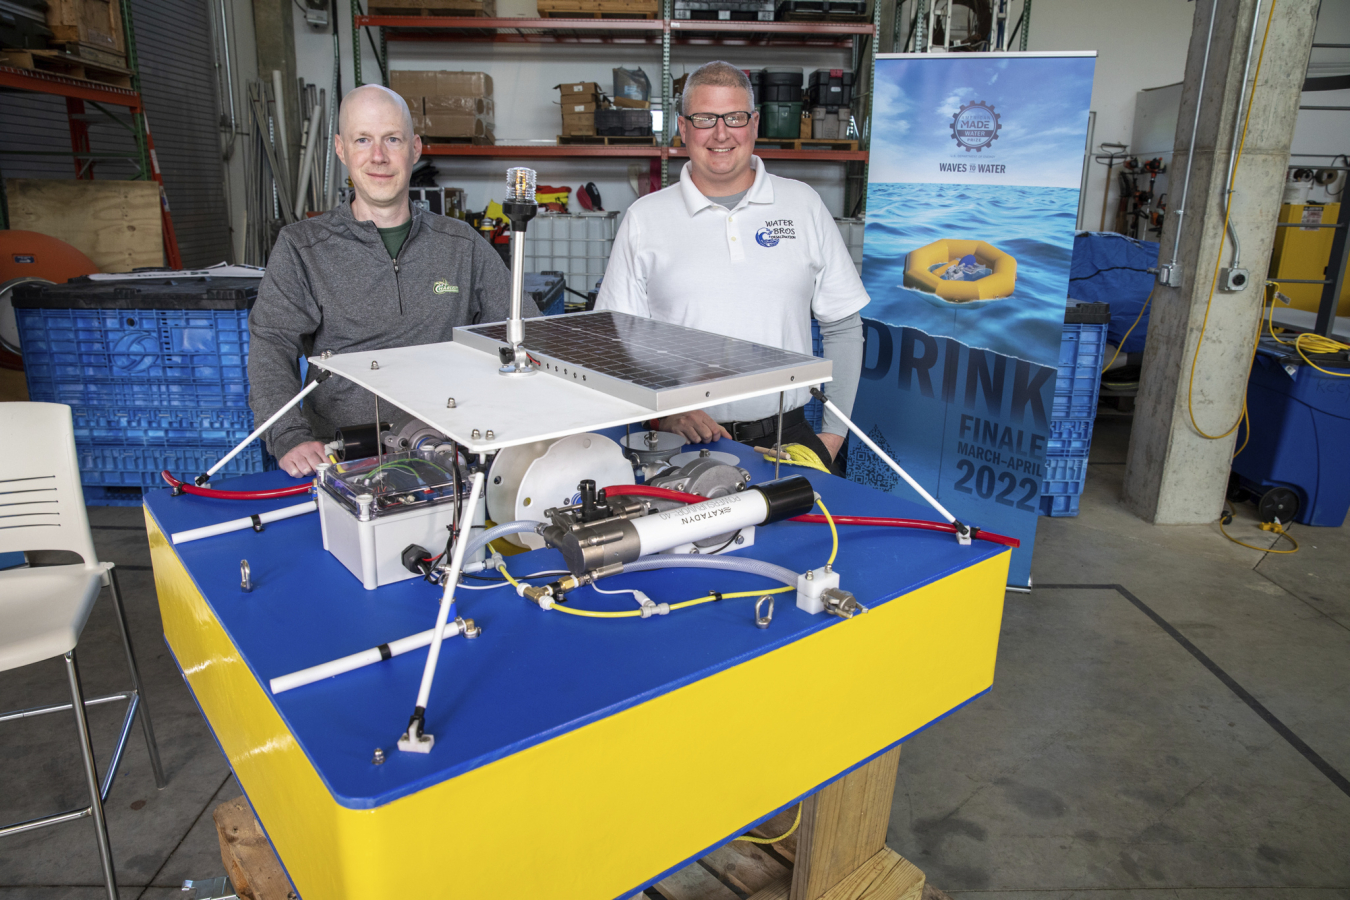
[{"x1": 248, "y1": 85, "x2": 539, "y2": 476}]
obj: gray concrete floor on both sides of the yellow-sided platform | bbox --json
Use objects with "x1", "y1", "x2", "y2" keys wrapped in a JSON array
[{"x1": 0, "y1": 417, "x2": 1350, "y2": 900}]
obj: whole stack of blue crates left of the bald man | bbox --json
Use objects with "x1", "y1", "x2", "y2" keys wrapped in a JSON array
[{"x1": 14, "y1": 278, "x2": 274, "y2": 506}]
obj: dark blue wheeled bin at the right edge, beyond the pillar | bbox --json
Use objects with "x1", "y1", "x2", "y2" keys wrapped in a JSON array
[{"x1": 1233, "y1": 339, "x2": 1350, "y2": 528}]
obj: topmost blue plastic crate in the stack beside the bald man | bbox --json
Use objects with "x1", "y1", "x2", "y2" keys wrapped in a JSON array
[{"x1": 15, "y1": 308, "x2": 248, "y2": 385}]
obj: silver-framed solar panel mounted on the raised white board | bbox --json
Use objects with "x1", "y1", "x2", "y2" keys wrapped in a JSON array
[{"x1": 454, "y1": 310, "x2": 832, "y2": 412}]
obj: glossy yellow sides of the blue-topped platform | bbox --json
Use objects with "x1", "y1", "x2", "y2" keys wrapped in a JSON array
[{"x1": 147, "y1": 515, "x2": 1010, "y2": 900}]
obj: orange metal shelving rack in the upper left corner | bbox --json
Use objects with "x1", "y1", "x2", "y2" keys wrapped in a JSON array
[{"x1": 0, "y1": 3, "x2": 182, "y2": 269}]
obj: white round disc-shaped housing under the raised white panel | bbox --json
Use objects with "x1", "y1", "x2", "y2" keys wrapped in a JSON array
[{"x1": 487, "y1": 433, "x2": 635, "y2": 551}]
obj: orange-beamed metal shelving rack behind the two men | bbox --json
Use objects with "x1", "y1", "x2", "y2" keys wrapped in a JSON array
[{"x1": 342, "y1": 0, "x2": 882, "y2": 212}]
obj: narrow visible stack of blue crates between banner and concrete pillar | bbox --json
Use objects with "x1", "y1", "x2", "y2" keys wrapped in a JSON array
[{"x1": 1041, "y1": 304, "x2": 1111, "y2": 515}]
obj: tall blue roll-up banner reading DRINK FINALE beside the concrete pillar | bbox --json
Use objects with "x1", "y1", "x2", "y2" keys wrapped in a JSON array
[{"x1": 848, "y1": 53, "x2": 1096, "y2": 587}]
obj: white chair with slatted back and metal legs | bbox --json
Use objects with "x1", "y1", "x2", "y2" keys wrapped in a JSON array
[{"x1": 0, "y1": 403, "x2": 166, "y2": 900}]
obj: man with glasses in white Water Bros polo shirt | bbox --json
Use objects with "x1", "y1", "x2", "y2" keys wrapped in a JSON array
[{"x1": 595, "y1": 62, "x2": 868, "y2": 464}]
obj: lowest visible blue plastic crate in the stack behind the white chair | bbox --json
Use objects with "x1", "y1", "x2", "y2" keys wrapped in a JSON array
[{"x1": 76, "y1": 441, "x2": 277, "y2": 488}]
